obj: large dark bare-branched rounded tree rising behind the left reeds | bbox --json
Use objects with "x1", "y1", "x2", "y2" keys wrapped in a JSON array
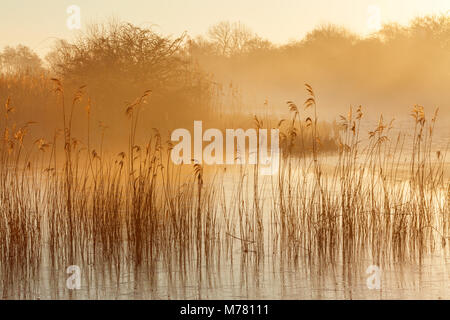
[{"x1": 47, "y1": 21, "x2": 214, "y2": 135}]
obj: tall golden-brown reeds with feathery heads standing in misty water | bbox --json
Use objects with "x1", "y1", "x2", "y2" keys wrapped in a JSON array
[{"x1": 0, "y1": 84, "x2": 450, "y2": 298}]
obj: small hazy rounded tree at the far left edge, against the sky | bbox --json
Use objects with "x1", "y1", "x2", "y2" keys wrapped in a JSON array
[{"x1": 0, "y1": 45, "x2": 43, "y2": 73}]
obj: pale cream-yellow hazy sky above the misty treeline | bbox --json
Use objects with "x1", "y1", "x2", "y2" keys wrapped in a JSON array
[{"x1": 0, "y1": 0, "x2": 450, "y2": 54}]
